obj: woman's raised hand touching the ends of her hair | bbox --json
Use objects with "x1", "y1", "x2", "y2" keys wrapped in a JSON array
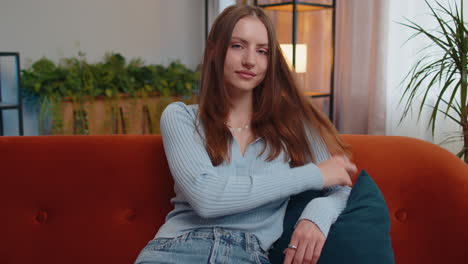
[{"x1": 317, "y1": 156, "x2": 357, "y2": 188}]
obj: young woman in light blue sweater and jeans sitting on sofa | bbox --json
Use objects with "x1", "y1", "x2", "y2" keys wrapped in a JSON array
[{"x1": 136, "y1": 5, "x2": 356, "y2": 263}]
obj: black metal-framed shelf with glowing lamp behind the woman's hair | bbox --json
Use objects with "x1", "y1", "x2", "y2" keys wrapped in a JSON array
[{"x1": 254, "y1": 0, "x2": 336, "y2": 122}]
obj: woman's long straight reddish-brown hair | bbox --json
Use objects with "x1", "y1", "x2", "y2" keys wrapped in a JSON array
[{"x1": 197, "y1": 5, "x2": 350, "y2": 167}]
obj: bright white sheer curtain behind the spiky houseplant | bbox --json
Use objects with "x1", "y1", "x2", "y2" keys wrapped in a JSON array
[{"x1": 386, "y1": 0, "x2": 468, "y2": 153}]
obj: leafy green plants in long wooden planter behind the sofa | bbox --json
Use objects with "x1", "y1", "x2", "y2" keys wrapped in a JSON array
[{"x1": 22, "y1": 52, "x2": 199, "y2": 135}]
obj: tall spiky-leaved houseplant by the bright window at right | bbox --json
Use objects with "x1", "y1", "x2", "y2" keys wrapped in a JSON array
[{"x1": 400, "y1": 0, "x2": 468, "y2": 164}]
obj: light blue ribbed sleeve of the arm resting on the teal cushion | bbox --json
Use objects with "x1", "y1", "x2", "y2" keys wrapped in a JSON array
[{"x1": 297, "y1": 126, "x2": 351, "y2": 237}]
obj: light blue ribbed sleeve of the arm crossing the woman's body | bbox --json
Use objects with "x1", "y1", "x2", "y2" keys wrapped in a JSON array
[{"x1": 161, "y1": 102, "x2": 323, "y2": 218}]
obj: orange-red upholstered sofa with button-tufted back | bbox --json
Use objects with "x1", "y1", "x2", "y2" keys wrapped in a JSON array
[{"x1": 0, "y1": 135, "x2": 468, "y2": 264}]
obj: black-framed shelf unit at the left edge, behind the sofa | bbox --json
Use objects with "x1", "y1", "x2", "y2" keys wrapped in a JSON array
[{"x1": 0, "y1": 52, "x2": 23, "y2": 136}]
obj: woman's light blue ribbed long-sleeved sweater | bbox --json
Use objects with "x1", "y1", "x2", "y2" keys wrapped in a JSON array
[{"x1": 156, "y1": 102, "x2": 351, "y2": 250}]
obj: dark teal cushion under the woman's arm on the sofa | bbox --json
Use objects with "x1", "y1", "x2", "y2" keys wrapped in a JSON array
[{"x1": 269, "y1": 170, "x2": 395, "y2": 264}]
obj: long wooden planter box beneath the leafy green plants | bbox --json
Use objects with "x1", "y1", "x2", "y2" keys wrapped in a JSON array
[{"x1": 52, "y1": 95, "x2": 195, "y2": 135}]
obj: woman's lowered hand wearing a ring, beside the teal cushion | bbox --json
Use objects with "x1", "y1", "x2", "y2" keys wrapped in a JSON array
[{"x1": 283, "y1": 219, "x2": 325, "y2": 264}]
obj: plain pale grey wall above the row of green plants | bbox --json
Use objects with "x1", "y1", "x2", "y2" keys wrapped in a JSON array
[{"x1": 0, "y1": 0, "x2": 204, "y2": 135}]
